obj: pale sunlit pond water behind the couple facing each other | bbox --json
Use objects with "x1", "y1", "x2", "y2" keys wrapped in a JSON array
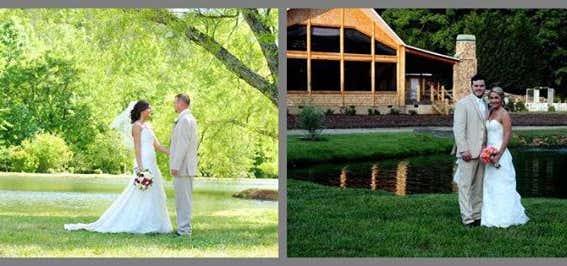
[{"x1": 0, "y1": 173, "x2": 278, "y2": 210}]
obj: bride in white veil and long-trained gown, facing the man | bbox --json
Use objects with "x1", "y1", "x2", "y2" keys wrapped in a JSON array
[{"x1": 64, "y1": 100, "x2": 173, "y2": 234}]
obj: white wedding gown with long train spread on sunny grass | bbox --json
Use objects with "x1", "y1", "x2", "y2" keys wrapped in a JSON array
[{"x1": 64, "y1": 122, "x2": 173, "y2": 234}]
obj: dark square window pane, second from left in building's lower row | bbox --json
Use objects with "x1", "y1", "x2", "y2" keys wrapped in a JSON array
[{"x1": 311, "y1": 60, "x2": 341, "y2": 91}]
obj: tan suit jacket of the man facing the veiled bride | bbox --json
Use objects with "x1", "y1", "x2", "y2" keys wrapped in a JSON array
[{"x1": 169, "y1": 109, "x2": 199, "y2": 176}]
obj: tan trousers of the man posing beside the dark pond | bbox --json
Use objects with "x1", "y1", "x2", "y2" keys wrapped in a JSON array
[{"x1": 457, "y1": 159, "x2": 484, "y2": 224}]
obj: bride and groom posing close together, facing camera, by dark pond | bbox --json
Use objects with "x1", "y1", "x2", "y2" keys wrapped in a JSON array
[{"x1": 453, "y1": 75, "x2": 529, "y2": 228}]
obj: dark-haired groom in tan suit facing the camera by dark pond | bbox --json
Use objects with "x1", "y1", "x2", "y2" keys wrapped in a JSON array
[{"x1": 453, "y1": 75, "x2": 488, "y2": 227}]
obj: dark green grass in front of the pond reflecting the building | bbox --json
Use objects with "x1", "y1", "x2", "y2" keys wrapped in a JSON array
[{"x1": 287, "y1": 180, "x2": 567, "y2": 257}]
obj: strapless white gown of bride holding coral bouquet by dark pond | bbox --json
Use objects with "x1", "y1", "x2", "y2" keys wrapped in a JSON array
[{"x1": 481, "y1": 120, "x2": 529, "y2": 228}]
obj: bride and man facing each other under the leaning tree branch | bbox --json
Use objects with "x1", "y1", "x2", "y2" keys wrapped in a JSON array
[{"x1": 64, "y1": 94, "x2": 198, "y2": 236}]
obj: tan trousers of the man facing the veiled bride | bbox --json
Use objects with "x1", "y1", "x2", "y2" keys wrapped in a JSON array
[{"x1": 173, "y1": 176, "x2": 193, "y2": 235}]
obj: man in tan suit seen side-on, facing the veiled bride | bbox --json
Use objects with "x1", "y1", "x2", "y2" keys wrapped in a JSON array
[{"x1": 169, "y1": 94, "x2": 199, "y2": 236}]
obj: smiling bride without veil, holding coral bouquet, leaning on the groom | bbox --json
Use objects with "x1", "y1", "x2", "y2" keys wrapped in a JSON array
[{"x1": 481, "y1": 87, "x2": 529, "y2": 228}]
